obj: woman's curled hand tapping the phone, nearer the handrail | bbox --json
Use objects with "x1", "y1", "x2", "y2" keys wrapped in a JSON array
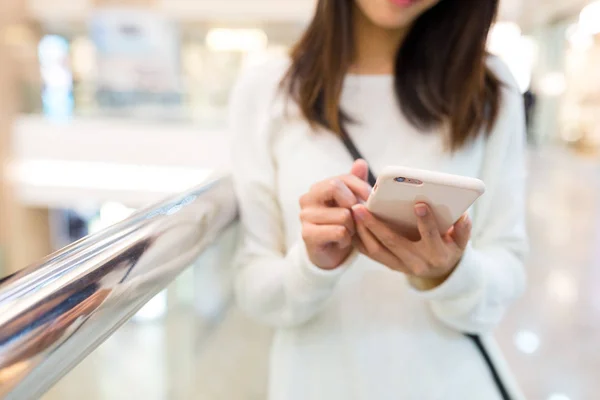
[{"x1": 300, "y1": 160, "x2": 371, "y2": 270}]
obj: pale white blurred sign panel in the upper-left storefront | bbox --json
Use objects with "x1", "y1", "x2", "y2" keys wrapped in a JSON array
[{"x1": 90, "y1": 8, "x2": 181, "y2": 114}]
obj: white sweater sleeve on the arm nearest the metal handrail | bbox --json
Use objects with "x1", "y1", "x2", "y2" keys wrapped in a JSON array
[{"x1": 229, "y1": 61, "x2": 351, "y2": 327}]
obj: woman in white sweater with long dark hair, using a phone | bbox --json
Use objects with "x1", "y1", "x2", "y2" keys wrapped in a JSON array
[{"x1": 232, "y1": 0, "x2": 527, "y2": 400}]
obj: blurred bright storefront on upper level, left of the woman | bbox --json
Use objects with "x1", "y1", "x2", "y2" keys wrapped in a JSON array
[{"x1": 23, "y1": 7, "x2": 303, "y2": 127}]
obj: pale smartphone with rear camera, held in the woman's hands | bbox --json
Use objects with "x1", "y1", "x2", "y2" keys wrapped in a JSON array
[{"x1": 366, "y1": 167, "x2": 485, "y2": 238}]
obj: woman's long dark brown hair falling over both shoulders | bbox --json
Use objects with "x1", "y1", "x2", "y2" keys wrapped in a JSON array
[{"x1": 283, "y1": 0, "x2": 501, "y2": 150}]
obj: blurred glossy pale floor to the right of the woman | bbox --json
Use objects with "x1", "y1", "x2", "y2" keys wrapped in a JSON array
[{"x1": 497, "y1": 147, "x2": 600, "y2": 400}]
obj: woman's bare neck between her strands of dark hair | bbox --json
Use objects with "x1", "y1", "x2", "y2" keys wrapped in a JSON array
[{"x1": 349, "y1": 5, "x2": 407, "y2": 75}]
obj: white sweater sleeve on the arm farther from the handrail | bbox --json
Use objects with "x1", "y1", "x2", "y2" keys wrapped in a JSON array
[{"x1": 418, "y1": 60, "x2": 528, "y2": 333}]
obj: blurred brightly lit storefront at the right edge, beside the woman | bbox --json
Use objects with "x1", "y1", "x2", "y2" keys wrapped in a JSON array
[{"x1": 532, "y1": 1, "x2": 600, "y2": 156}]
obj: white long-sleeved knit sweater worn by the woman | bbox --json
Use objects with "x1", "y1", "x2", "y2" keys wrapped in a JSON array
[{"x1": 231, "y1": 59, "x2": 527, "y2": 400}]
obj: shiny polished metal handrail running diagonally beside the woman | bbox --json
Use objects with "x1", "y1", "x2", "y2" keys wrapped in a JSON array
[{"x1": 0, "y1": 176, "x2": 236, "y2": 400}]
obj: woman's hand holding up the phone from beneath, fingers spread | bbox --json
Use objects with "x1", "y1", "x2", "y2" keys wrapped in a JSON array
[{"x1": 352, "y1": 203, "x2": 471, "y2": 290}]
